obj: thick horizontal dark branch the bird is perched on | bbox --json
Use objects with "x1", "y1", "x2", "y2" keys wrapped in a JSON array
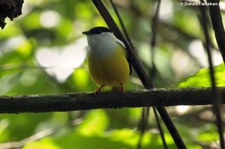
[{"x1": 0, "y1": 88, "x2": 225, "y2": 113}]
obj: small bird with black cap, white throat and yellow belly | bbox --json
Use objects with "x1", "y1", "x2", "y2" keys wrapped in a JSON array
[{"x1": 83, "y1": 27, "x2": 131, "y2": 93}]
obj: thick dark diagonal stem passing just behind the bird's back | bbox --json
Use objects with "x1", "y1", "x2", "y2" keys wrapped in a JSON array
[{"x1": 92, "y1": 0, "x2": 186, "y2": 149}]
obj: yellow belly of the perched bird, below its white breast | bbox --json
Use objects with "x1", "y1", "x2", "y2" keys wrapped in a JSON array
[{"x1": 88, "y1": 48, "x2": 130, "y2": 86}]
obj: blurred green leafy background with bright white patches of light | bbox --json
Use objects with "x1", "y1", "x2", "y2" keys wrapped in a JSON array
[{"x1": 0, "y1": 0, "x2": 225, "y2": 149}]
